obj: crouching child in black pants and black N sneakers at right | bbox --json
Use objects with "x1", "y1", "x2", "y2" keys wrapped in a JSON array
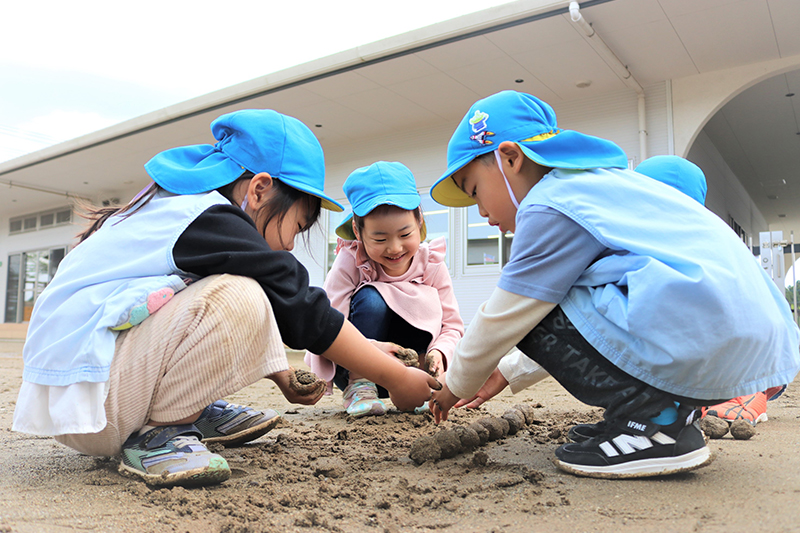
[{"x1": 430, "y1": 91, "x2": 800, "y2": 478}]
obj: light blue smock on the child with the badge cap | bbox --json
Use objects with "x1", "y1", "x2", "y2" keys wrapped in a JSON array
[{"x1": 520, "y1": 169, "x2": 800, "y2": 400}]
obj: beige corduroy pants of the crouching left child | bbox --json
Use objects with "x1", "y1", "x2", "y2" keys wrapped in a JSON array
[{"x1": 56, "y1": 274, "x2": 289, "y2": 456}]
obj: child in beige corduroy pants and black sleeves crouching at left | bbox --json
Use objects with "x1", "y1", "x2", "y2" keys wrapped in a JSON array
[{"x1": 13, "y1": 110, "x2": 437, "y2": 486}]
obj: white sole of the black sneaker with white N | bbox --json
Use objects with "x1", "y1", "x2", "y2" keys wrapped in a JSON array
[{"x1": 553, "y1": 446, "x2": 714, "y2": 479}]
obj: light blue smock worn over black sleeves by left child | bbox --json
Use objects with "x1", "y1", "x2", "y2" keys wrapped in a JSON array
[{"x1": 22, "y1": 191, "x2": 230, "y2": 386}]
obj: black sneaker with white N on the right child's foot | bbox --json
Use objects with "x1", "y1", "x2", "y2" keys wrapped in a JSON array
[{"x1": 555, "y1": 408, "x2": 713, "y2": 479}]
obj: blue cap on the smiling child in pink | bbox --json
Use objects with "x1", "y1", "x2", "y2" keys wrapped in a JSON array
[{"x1": 336, "y1": 161, "x2": 425, "y2": 241}]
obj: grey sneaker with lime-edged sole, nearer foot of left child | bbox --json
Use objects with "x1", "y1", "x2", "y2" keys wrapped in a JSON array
[{"x1": 119, "y1": 424, "x2": 231, "y2": 487}]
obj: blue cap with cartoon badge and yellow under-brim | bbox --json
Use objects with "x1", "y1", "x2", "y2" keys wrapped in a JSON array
[{"x1": 431, "y1": 91, "x2": 628, "y2": 207}]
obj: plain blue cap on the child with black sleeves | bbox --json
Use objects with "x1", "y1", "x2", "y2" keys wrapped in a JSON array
[{"x1": 144, "y1": 109, "x2": 344, "y2": 211}]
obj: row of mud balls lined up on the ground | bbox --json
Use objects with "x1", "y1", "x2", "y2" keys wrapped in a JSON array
[{"x1": 408, "y1": 404, "x2": 534, "y2": 465}]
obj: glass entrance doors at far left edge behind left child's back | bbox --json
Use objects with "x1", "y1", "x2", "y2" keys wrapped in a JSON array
[{"x1": 5, "y1": 248, "x2": 67, "y2": 322}]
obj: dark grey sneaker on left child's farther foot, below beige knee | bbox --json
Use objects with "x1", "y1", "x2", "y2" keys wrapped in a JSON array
[{"x1": 194, "y1": 400, "x2": 281, "y2": 446}]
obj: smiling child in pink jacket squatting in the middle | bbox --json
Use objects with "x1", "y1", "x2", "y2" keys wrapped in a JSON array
[{"x1": 306, "y1": 161, "x2": 464, "y2": 417}]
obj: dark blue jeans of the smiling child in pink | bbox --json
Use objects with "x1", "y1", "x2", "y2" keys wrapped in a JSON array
[{"x1": 333, "y1": 285, "x2": 432, "y2": 398}]
